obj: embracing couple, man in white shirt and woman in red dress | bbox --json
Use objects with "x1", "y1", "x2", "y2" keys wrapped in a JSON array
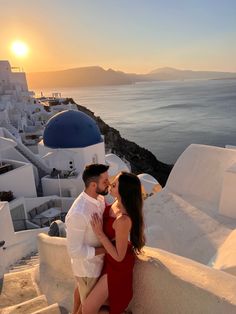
[{"x1": 66, "y1": 164, "x2": 145, "y2": 314}]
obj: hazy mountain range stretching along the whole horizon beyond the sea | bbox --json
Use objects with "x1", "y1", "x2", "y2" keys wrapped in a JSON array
[{"x1": 26, "y1": 66, "x2": 236, "y2": 89}]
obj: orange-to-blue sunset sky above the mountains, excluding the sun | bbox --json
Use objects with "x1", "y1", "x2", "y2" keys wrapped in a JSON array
[{"x1": 0, "y1": 0, "x2": 236, "y2": 73}]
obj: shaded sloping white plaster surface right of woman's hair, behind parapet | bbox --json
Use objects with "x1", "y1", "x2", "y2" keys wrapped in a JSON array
[{"x1": 144, "y1": 188, "x2": 232, "y2": 264}]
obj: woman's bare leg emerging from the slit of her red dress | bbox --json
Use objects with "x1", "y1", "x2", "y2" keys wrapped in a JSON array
[{"x1": 82, "y1": 275, "x2": 109, "y2": 314}]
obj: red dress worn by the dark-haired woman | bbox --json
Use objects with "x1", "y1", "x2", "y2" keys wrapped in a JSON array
[{"x1": 102, "y1": 205, "x2": 135, "y2": 314}]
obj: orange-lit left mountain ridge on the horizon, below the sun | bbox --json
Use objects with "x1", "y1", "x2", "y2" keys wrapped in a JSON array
[{"x1": 26, "y1": 66, "x2": 132, "y2": 88}]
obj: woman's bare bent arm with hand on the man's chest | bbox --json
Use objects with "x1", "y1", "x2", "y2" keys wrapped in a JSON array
[{"x1": 91, "y1": 214, "x2": 131, "y2": 262}]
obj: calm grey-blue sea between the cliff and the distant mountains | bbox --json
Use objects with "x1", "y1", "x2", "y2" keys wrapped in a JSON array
[{"x1": 36, "y1": 80, "x2": 236, "y2": 163}]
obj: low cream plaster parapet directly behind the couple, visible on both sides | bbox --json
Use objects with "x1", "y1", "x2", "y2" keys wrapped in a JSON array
[{"x1": 38, "y1": 234, "x2": 236, "y2": 314}]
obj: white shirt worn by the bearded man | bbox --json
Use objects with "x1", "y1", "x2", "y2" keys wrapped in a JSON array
[{"x1": 65, "y1": 192, "x2": 105, "y2": 278}]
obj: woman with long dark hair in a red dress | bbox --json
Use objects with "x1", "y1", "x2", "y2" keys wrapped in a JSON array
[{"x1": 82, "y1": 172, "x2": 145, "y2": 314}]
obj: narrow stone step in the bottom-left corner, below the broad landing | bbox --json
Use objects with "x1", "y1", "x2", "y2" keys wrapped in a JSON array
[{"x1": 1, "y1": 295, "x2": 48, "y2": 314}]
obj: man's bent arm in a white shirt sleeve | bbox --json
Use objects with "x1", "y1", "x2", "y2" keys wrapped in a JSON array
[{"x1": 66, "y1": 213, "x2": 95, "y2": 259}]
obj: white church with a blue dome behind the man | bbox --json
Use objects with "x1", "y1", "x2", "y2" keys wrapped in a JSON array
[{"x1": 39, "y1": 110, "x2": 105, "y2": 196}]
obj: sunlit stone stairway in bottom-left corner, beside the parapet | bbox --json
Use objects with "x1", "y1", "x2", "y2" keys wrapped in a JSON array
[{"x1": 0, "y1": 253, "x2": 65, "y2": 314}]
